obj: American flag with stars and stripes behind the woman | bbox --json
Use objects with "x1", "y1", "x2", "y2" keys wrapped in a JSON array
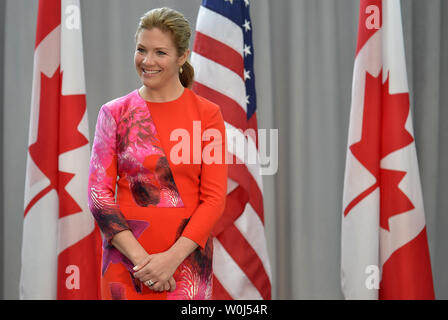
[{"x1": 191, "y1": 0, "x2": 271, "y2": 300}]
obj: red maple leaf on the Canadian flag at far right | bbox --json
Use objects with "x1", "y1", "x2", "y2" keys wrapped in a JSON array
[{"x1": 344, "y1": 72, "x2": 414, "y2": 230}]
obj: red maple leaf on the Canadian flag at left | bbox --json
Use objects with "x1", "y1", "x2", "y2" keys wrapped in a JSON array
[{"x1": 25, "y1": 68, "x2": 88, "y2": 217}]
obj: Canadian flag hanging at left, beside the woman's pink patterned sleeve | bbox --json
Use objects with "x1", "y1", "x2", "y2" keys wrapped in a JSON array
[{"x1": 20, "y1": 0, "x2": 100, "y2": 299}]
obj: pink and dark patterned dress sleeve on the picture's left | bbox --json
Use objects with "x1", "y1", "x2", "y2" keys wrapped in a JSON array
[{"x1": 88, "y1": 106, "x2": 129, "y2": 242}]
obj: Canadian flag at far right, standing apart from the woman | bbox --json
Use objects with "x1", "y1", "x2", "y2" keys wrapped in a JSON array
[{"x1": 341, "y1": 0, "x2": 434, "y2": 299}]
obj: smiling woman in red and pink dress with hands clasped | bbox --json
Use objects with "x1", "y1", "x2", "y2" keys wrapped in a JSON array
[{"x1": 89, "y1": 8, "x2": 227, "y2": 299}]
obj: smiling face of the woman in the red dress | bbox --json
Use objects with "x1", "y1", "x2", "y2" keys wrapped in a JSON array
[{"x1": 134, "y1": 28, "x2": 188, "y2": 90}]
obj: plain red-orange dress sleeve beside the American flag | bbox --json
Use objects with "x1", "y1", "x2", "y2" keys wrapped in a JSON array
[{"x1": 182, "y1": 107, "x2": 227, "y2": 248}]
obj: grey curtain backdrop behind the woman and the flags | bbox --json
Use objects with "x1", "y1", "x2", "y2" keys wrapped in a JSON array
[{"x1": 0, "y1": 0, "x2": 448, "y2": 299}]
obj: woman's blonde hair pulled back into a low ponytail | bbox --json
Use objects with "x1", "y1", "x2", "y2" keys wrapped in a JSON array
[{"x1": 135, "y1": 7, "x2": 194, "y2": 88}]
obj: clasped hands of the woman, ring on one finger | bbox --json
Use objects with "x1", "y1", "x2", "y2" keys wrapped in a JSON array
[{"x1": 133, "y1": 251, "x2": 181, "y2": 292}]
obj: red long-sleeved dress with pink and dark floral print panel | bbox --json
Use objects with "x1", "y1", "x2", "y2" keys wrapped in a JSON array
[{"x1": 88, "y1": 88, "x2": 227, "y2": 299}]
